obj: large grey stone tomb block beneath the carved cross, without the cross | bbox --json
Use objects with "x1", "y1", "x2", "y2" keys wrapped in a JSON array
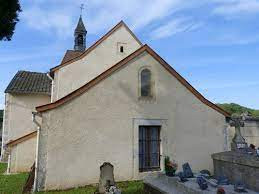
[{"x1": 212, "y1": 151, "x2": 259, "y2": 192}]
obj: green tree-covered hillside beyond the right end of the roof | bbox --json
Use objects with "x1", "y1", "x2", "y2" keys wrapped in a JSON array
[{"x1": 217, "y1": 103, "x2": 259, "y2": 117}]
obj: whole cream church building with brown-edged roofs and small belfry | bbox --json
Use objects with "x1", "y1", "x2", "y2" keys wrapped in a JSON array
[{"x1": 3, "y1": 16, "x2": 230, "y2": 190}]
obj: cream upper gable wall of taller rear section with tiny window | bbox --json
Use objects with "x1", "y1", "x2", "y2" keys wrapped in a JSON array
[{"x1": 52, "y1": 25, "x2": 141, "y2": 101}]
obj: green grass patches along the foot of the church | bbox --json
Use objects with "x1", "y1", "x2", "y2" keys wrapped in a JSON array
[{"x1": 0, "y1": 163, "x2": 144, "y2": 194}]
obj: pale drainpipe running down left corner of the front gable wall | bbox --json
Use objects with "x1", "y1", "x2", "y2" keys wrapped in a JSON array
[{"x1": 32, "y1": 112, "x2": 41, "y2": 192}]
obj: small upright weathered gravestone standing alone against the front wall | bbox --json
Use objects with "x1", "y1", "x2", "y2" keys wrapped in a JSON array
[{"x1": 98, "y1": 162, "x2": 115, "y2": 193}]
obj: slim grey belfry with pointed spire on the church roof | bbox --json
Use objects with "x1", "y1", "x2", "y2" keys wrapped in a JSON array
[{"x1": 74, "y1": 5, "x2": 87, "y2": 51}]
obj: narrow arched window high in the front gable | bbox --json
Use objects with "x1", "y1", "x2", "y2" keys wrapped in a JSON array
[{"x1": 140, "y1": 69, "x2": 152, "y2": 97}]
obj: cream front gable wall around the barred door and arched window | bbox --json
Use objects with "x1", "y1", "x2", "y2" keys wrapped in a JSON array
[{"x1": 37, "y1": 50, "x2": 226, "y2": 190}]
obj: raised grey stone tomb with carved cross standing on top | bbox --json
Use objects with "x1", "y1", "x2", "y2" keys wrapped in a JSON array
[{"x1": 212, "y1": 117, "x2": 259, "y2": 192}]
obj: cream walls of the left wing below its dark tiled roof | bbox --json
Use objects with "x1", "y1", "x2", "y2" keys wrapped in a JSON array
[{"x1": 1, "y1": 93, "x2": 50, "y2": 173}]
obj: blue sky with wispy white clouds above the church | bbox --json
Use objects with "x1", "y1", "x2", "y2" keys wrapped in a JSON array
[{"x1": 0, "y1": 0, "x2": 259, "y2": 109}]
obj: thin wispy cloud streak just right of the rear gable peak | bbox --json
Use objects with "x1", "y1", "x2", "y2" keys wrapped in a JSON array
[{"x1": 151, "y1": 18, "x2": 203, "y2": 39}]
